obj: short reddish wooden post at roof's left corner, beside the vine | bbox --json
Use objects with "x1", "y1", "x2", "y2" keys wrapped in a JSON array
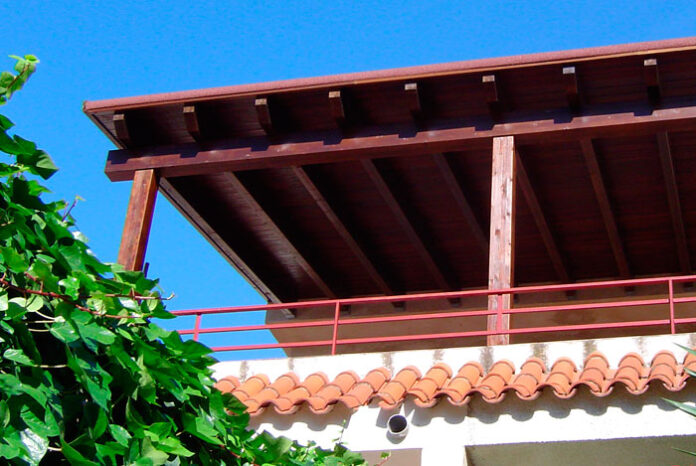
[{"x1": 118, "y1": 170, "x2": 157, "y2": 270}]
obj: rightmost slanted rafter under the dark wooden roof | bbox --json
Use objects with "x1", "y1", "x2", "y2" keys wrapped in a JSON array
[{"x1": 657, "y1": 132, "x2": 692, "y2": 275}]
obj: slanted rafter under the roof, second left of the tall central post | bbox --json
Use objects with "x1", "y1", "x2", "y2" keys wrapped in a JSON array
[{"x1": 361, "y1": 160, "x2": 453, "y2": 290}]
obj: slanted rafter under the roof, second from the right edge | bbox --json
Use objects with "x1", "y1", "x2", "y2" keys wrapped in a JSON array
[{"x1": 580, "y1": 139, "x2": 631, "y2": 278}]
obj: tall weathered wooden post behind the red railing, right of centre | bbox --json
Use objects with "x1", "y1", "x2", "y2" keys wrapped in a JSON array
[{"x1": 488, "y1": 136, "x2": 515, "y2": 345}]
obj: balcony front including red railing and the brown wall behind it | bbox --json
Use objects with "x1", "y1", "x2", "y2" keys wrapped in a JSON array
[{"x1": 173, "y1": 275, "x2": 696, "y2": 359}]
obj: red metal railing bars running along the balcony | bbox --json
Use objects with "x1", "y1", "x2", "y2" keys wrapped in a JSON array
[{"x1": 172, "y1": 275, "x2": 696, "y2": 354}]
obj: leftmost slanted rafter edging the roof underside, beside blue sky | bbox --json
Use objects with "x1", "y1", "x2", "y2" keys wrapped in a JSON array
[{"x1": 159, "y1": 178, "x2": 294, "y2": 318}]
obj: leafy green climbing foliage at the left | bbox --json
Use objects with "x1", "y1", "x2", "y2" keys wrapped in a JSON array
[{"x1": 0, "y1": 55, "x2": 364, "y2": 466}]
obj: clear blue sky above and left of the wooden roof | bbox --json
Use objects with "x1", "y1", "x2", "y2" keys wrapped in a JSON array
[{"x1": 0, "y1": 0, "x2": 696, "y2": 358}]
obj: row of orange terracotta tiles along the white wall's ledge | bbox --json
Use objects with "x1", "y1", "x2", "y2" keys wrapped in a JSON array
[{"x1": 216, "y1": 351, "x2": 696, "y2": 415}]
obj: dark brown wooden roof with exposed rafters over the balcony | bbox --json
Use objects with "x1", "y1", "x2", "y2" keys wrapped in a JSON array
[{"x1": 84, "y1": 38, "x2": 696, "y2": 302}]
